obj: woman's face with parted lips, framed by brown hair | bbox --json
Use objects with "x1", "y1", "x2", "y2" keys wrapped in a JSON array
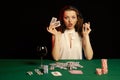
[{"x1": 63, "y1": 10, "x2": 77, "y2": 29}]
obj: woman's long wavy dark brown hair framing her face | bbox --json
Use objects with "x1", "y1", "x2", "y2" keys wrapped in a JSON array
[{"x1": 58, "y1": 5, "x2": 83, "y2": 36}]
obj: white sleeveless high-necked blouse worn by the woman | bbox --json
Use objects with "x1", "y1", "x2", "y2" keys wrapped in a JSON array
[{"x1": 60, "y1": 29, "x2": 82, "y2": 59}]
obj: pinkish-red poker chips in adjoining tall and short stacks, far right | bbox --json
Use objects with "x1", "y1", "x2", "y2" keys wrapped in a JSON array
[{"x1": 96, "y1": 59, "x2": 108, "y2": 75}]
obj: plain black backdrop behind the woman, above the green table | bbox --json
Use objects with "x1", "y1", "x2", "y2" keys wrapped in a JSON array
[{"x1": 0, "y1": 0, "x2": 116, "y2": 59}]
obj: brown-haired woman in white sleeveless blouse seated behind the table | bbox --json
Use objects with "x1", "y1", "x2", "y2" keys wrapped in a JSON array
[{"x1": 47, "y1": 6, "x2": 93, "y2": 61}]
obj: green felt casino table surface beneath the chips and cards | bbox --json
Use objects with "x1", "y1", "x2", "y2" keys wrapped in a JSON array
[{"x1": 0, "y1": 59, "x2": 120, "y2": 80}]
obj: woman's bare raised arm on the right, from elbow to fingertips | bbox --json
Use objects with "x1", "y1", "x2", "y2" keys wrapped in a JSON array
[{"x1": 82, "y1": 22, "x2": 93, "y2": 60}]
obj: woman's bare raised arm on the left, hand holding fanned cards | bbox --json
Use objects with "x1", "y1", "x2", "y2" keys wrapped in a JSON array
[{"x1": 47, "y1": 17, "x2": 61, "y2": 61}]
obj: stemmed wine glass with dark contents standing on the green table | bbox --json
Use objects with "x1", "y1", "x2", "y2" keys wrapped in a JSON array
[{"x1": 37, "y1": 45, "x2": 48, "y2": 68}]
